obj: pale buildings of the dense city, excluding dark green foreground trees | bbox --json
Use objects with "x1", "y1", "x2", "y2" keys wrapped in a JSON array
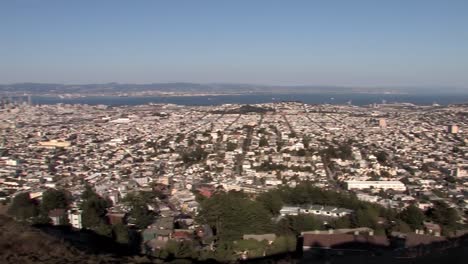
[{"x1": 0, "y1": 99, "x2": 468, "y2": 258}]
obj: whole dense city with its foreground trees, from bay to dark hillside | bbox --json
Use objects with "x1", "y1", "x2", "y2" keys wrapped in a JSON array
[{"x1": 0, "y1": 101, "x2": 468, "y2": 262}]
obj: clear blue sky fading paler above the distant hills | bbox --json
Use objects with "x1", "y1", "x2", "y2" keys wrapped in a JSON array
[{"x1": 0, "y1": 0, "x2": 468, "y2": 89}]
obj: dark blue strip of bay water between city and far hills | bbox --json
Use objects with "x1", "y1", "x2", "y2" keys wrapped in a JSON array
[{"x1": 32, "y1": 94, "x2": 468, "y2": 106}]
